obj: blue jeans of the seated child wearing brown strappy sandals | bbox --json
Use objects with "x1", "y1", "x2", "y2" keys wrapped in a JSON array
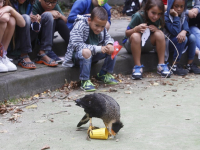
[{"x1": 15, "y1": 12, "x2": 54, "y2": 53}]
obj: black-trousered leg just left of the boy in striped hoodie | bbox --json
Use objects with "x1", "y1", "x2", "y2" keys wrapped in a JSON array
[{"x1": 53, "y1": 19, "x2": 70, "y2": 45}]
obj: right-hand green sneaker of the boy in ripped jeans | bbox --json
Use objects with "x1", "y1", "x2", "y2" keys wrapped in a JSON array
[{"x1": 97, "y1": 73, "x2": 118, "y2": 84}]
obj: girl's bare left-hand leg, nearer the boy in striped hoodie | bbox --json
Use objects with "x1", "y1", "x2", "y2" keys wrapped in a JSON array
[{"x1": 129, "y1": 33, "x2": 141, "y2": 66}]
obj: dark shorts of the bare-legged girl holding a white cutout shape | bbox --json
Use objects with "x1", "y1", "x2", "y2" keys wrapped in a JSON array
[{"x1": 124, "y1": 37, "x2": 156, "y2": 54}]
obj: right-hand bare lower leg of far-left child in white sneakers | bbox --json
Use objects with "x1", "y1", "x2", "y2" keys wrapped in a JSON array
[{"x1": 1, "y1": 16, "x2": 16, "y2": 51}]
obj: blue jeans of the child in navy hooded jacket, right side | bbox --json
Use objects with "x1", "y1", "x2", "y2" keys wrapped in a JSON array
[{"x1": 169, "y1": 34, "x2": 196, "y2": 62}]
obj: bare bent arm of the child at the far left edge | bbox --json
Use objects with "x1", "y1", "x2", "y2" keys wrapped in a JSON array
[{"x1": 0, "y1": 6, "x2": 26, "y2": 27}]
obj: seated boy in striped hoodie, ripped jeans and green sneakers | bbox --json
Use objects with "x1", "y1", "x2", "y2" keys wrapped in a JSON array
[{"x1": 62, "y1": 7, "x2": 118, "y2": 91}]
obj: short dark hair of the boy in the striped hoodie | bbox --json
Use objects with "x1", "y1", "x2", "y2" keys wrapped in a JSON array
[{"x1": 91, "y1": 7, "x2": 108, "y2": 20}]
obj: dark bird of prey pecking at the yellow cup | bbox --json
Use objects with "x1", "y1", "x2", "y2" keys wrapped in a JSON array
[{"x1": 75, "y1": 93, "x2": 123, "y2": 136}]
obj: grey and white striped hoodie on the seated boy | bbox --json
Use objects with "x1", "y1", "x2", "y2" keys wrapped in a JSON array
[{"x1": 62, "y1": 15, "x2": 114, "y2": 67}]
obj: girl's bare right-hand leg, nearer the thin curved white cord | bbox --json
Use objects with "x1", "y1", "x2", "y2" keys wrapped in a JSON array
[{"x1": 151, "y1": 30, "x2": 165, "y2": 64}]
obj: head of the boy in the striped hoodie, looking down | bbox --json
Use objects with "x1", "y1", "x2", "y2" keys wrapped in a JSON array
[{"x1": 88, "y1": 7, "x2": 108, "y2": 34}]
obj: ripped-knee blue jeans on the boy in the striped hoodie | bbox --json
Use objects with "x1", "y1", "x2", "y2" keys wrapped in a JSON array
[{"x1": 74, "y1": 51, "x2": 117, "y2": 80}]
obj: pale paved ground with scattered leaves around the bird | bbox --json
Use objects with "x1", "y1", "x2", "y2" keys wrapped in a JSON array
[{"x1": 0, "y1": 74, "x2": 200, "y2": 150}]
